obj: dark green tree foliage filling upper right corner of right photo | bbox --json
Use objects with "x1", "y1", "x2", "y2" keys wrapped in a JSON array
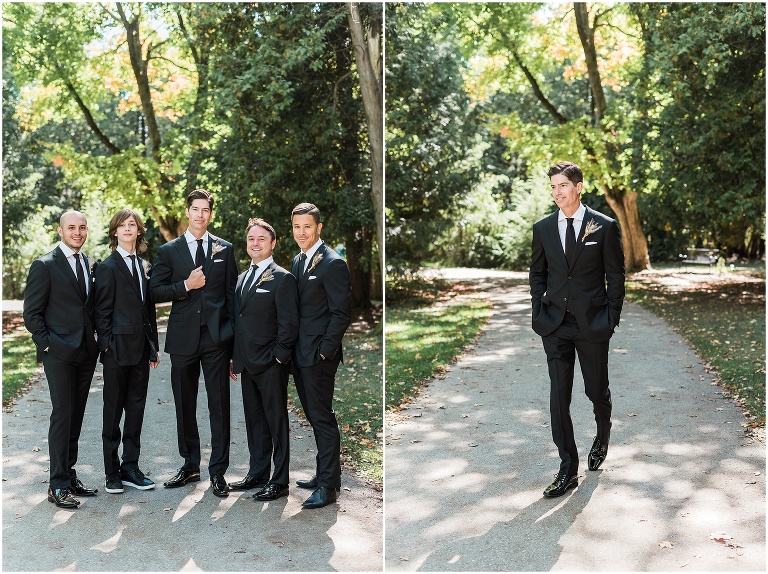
[{"x1": 633, "y1": 3, "x2": 766, "y2": 259}]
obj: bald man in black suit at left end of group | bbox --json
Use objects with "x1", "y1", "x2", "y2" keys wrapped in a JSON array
[{"x1": 24, "y1": 211, "x2": 98, "y2": 508}]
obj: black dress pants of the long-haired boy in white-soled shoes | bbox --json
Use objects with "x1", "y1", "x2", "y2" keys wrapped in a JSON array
[{"x1": 101, "y1": 344, "x2": 149, "y2": 476}]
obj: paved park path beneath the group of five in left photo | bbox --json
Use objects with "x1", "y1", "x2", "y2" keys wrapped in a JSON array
[{"x1": 2, "y1": 318, "x2": 383, "y2": 572}]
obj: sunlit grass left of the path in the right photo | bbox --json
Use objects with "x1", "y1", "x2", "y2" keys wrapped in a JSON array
[{"x1": 385, "y1": 284, "x2": 490, "y2": 409}]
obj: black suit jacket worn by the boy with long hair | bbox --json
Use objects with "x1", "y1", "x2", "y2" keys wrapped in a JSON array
[{"x1": 94, "y1": 251, "x2": 159, "y2": 367}]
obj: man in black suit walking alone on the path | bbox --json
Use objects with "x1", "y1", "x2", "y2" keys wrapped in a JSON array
[{"x1": 530, "y1": 162, "x2": 624, "y2": 497}]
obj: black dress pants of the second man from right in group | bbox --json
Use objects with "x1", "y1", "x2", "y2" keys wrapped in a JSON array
[{"x1": 242, "y1": 362, "x2": 290, "y2": 484}]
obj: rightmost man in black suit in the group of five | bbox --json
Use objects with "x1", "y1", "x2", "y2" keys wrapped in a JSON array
[{"x1": 291, "y1": 203, "x2": 352, "y2": 508}]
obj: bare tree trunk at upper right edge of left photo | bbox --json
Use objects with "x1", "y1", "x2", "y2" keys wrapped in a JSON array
[{"x1": 347, "y1": 2, "x2": 384, "y2": 282}]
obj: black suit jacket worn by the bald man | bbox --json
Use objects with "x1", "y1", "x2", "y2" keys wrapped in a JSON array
[{"x1": 23, "y1": 247, "x2": 98, "y2": 361}]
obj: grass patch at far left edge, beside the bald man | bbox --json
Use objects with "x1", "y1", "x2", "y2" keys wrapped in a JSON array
[{"x1": 3, "y1": 313, "x2": 37, "y2": 406}]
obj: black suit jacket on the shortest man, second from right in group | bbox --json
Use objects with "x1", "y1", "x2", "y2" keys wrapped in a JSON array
[{"x1": 232, "y1": 261, "x2": 299, "y2": 375}]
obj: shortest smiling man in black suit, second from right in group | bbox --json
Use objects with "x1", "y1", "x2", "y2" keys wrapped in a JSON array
[{"x1": 229, "y1": 219, "x2": 299, "y2": 500}]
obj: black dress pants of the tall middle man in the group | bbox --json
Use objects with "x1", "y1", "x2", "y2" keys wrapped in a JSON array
[{"x1": 171, "y1": 328, "x2": 231, "y2": 475}]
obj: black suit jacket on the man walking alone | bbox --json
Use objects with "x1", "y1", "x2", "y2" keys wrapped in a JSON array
[{"x1": 529, "y1": 207, "x2": 624, "y2": 343}]
